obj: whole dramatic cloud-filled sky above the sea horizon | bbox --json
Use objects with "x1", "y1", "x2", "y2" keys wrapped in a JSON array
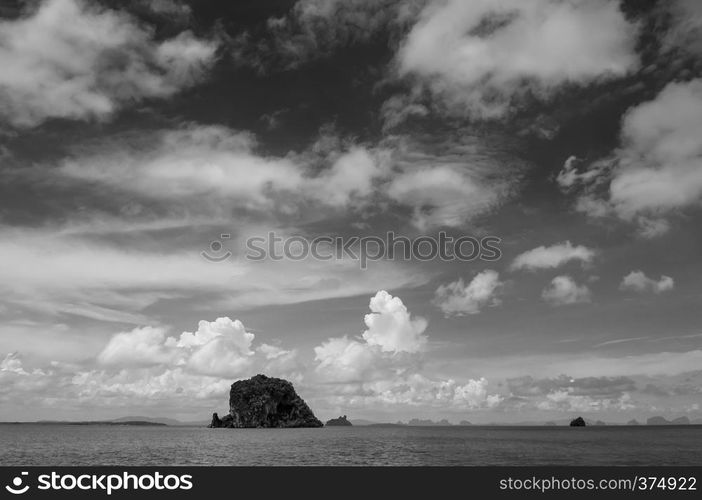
[{"x1": 0, "y1": 0, "x2": 702, "y2": 423}]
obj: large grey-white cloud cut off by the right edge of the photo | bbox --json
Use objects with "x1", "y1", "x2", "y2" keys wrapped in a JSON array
[{"x1": 559, "y1": 79, "x2": 702, "y2": 238}]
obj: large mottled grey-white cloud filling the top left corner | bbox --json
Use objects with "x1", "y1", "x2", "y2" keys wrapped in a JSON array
[{"x1": 0, "y1": 0, "x2": 217, "y2": 127}]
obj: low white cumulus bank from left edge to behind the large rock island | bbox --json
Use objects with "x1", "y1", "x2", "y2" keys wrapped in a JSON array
[{"x1": 0, "y1": 317, "x2": 303, "y2": 419}]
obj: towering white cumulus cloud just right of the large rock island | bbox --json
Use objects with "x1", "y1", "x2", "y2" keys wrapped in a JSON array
[{"x1": 314, "y1": 291, "x2": 501, "y2": 409}]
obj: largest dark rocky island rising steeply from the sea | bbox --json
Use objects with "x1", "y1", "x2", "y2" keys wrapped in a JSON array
[{"x1": 208, "y1": 374, "x2": 324, "y2": 428}]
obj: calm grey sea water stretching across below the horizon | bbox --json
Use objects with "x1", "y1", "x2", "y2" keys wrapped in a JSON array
[{"x1": 0, "y1": 424, "x2": 702, "y2": 466}]
